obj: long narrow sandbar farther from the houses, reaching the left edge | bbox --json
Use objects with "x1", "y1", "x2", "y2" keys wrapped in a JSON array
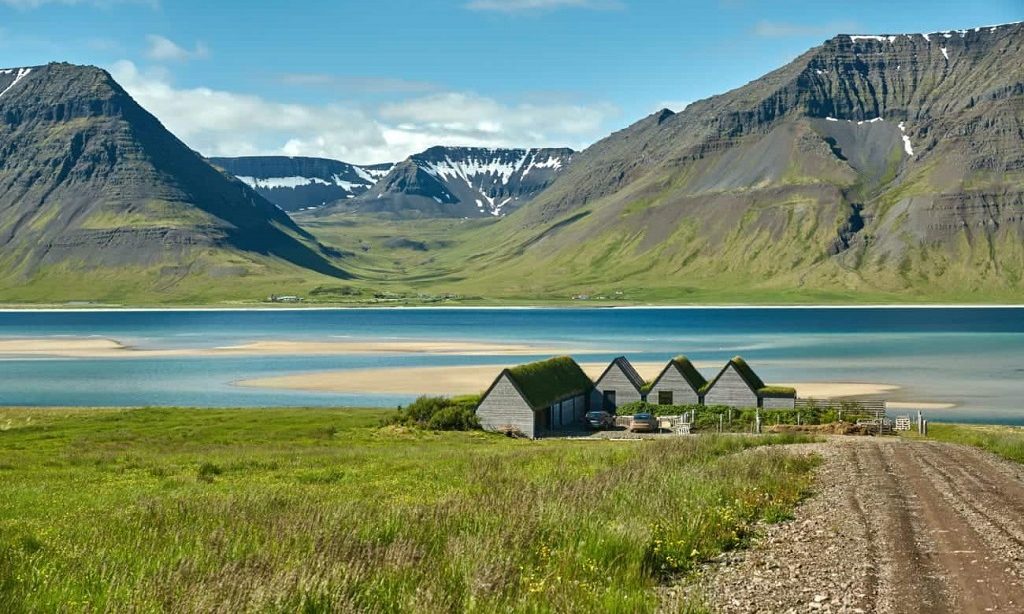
[{"x1": 0, "y1": 337, "x2": 571, "y2": 358}]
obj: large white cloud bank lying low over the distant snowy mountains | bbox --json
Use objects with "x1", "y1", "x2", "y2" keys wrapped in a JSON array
[{"x1": 112, "y1": 60, "x2": 617, "y2": 164}]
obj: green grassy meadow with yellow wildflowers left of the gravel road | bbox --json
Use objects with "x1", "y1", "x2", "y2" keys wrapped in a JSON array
[{"x1": 0, "y1": 409, "x2": 814, "y2": 612}]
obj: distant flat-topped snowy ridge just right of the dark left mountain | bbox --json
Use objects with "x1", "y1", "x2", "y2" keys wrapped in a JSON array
[{"x1": 210, "y1": 156, "x2": 394, "y2": 211}]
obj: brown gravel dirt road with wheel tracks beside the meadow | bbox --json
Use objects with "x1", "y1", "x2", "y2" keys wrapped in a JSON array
[{"x1": 686, "y1": 437, "x2": 1024, "y2": 613}]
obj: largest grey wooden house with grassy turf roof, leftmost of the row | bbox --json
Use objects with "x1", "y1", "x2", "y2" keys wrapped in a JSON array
[{"x1": 476, "y1": 356, "x2": 594, "y2": 439}]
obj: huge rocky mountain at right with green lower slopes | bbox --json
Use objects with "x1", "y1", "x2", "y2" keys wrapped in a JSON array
[{"x1": 438, "y1": 24, "x2": 1024, "y2": 301}]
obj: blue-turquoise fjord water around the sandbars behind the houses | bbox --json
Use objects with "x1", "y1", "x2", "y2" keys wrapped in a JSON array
[{"x1": 0, "y1": 307, "x2": 1024, "y2": 424}]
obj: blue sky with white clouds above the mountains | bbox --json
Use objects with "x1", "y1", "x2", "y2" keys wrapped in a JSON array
[{"x1": 0, "y1": 0, "x2": 1024, "y2": 164}]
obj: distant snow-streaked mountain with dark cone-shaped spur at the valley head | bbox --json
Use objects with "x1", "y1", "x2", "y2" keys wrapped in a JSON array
[{"x1": 323, "y1": 146, "x2": 573, "y2": 218}]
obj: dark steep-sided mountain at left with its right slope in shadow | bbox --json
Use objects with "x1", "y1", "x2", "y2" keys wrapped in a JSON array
[{"x1": 0, "y1": 63, "x2": 345, "y2": 297}]
